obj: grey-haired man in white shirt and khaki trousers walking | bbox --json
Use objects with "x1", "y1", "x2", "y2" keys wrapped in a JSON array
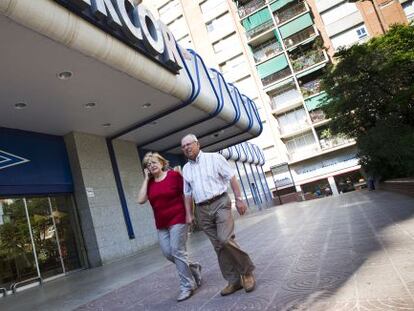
[{"x1": 181, "y1": 134, "x2": 256, "y2": 296}]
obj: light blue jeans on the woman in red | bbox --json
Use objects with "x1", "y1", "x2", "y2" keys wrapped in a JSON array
[{"x1": 158, "y1": 224, "x2": 197, "y2": 291}]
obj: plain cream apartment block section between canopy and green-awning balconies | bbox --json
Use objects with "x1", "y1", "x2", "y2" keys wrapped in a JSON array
[{"x1": 143, "y1": 0, "x2": 286, "y2": 193}]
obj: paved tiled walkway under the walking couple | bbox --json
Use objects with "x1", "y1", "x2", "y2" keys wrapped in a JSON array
[{"x1": 0, "y1": 191, "x2": 414, "y2": 311}]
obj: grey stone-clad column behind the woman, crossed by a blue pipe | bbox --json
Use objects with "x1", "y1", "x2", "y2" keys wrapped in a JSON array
[{"x1": 65, "y1": 133, "x2": 157, "y2": 267}]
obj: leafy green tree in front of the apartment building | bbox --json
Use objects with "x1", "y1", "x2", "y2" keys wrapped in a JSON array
[{"x1": 321, "y1": 25, "x2": 414, "y2": 178}]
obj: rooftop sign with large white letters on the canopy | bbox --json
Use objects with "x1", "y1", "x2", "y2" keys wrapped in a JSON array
[{"x1": 55, "y1": 0, "x2": 182, "y2": 74}]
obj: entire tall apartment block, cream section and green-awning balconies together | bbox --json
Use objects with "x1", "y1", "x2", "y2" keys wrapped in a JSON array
[{"x1": 144, "y1": 0, "x2": 407, "y2": 201}]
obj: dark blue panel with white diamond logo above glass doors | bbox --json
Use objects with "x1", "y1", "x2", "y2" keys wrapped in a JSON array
[{"x1": 0, "y1": 127, "x2": 73, "y2": 197}]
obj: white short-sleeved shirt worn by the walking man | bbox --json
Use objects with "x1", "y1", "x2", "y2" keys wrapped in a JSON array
[{"x1": 183, "y1": 151, "x2": 235, "y2": 203}]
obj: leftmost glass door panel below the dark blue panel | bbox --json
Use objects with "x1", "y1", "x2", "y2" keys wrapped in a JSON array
[{"x1": 0, "y1": 198, "x2": 39, "y2": 289}]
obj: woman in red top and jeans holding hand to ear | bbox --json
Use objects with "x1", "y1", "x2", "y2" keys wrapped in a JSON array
[{"x1": 138, "y1": 152, "x2": 201, "y2": 301}]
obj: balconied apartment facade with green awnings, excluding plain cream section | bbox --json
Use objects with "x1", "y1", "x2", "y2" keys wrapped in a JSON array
[{"x1": 234, "y1": 0, "x2": 407, "y2": 200}]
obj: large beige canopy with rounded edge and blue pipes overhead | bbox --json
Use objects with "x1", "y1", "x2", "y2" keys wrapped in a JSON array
[{"x1": 0, "y1": 0, "x2": 262, "y2": 153}]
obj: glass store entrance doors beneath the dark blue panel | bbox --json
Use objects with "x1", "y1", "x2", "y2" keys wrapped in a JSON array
[{"x1": 0, "y1": 195, "x2": 82, "y2": 292}]
